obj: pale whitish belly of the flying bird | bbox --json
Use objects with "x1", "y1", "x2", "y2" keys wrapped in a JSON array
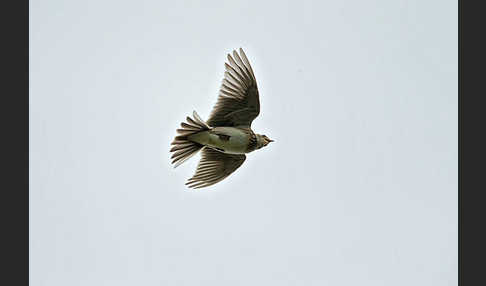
[{"x1": 188, "y1": 127, "x2": 250, "y2": 154}]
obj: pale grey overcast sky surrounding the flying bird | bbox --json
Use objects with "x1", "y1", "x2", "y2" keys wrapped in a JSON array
[{"x1": 30, "y1": 0, "x2": 458, "y2": 286}]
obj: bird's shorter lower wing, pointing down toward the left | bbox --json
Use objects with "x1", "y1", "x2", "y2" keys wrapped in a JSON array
[{"x1": 186, "y1": 147, "x2": 246, "y2": 189}]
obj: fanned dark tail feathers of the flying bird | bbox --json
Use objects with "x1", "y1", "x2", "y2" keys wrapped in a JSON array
[{"x1": 170, "y1": 111, "x2": 210, "y2": 168}]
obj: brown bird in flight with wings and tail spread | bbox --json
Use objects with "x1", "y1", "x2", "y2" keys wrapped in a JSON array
[{"x1": 170, "y1": 48, "x2": 274, "y2": 189}]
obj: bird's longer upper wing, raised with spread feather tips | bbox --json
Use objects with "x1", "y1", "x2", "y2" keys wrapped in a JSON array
[{"x1": 207, "y1": 48, "x2": 260, "y2": 127}]
